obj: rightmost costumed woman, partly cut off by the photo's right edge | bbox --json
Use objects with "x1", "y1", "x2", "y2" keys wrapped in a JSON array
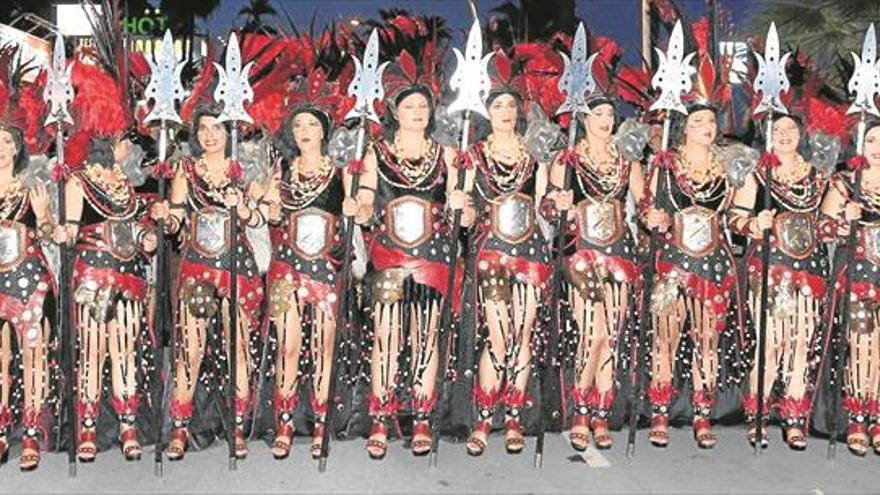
[{"x1": 822, "y1": 118, "x2": 880, "y2": 456}]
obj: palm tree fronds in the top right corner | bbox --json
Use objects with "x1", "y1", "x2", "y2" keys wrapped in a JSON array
[{"x1": 749, "y1": 0, "x2": 880, "y2": 88}]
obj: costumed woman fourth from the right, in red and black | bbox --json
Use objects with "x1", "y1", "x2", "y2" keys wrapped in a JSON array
[{"x1": 544, "y1": 93, "x2": 644, "y2": 451}]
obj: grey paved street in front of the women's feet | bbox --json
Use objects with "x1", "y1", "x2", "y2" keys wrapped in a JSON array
[{"x1": 0, "y1": 427, "x2": 880, "y2": 494}]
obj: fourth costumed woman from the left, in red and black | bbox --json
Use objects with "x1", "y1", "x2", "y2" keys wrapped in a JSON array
[{"x1": 267, "y1": 68, "x2": 349, "y2": 459}]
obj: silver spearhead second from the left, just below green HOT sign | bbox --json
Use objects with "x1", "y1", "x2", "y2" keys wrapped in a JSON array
[{"x1": 144, "y1": 30, "x2": 186, "y2": 124}]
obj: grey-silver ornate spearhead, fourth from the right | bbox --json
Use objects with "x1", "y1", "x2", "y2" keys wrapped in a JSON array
[{"x1": 556, "y1": 23, "x2": 599, "y2": 115}]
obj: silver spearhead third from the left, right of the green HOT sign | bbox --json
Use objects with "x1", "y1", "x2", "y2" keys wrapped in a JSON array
[{"x1": 214, "y1": 33, "x2": 254, "y2": 124}]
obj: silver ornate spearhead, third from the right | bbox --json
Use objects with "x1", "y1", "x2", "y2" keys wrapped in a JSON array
[{"x1": 650, "y1": 21, "x2": 697, "y2": 115}]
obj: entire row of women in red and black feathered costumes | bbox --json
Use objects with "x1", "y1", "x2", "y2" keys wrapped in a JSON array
[{"x1": 0, "y1": 7, "x2": 880, "y2": 470}]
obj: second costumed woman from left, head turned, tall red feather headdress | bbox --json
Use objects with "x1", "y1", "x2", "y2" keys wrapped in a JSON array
[{"x1": 63, "y1": 55, "x2": 156, "y2": 462}]
